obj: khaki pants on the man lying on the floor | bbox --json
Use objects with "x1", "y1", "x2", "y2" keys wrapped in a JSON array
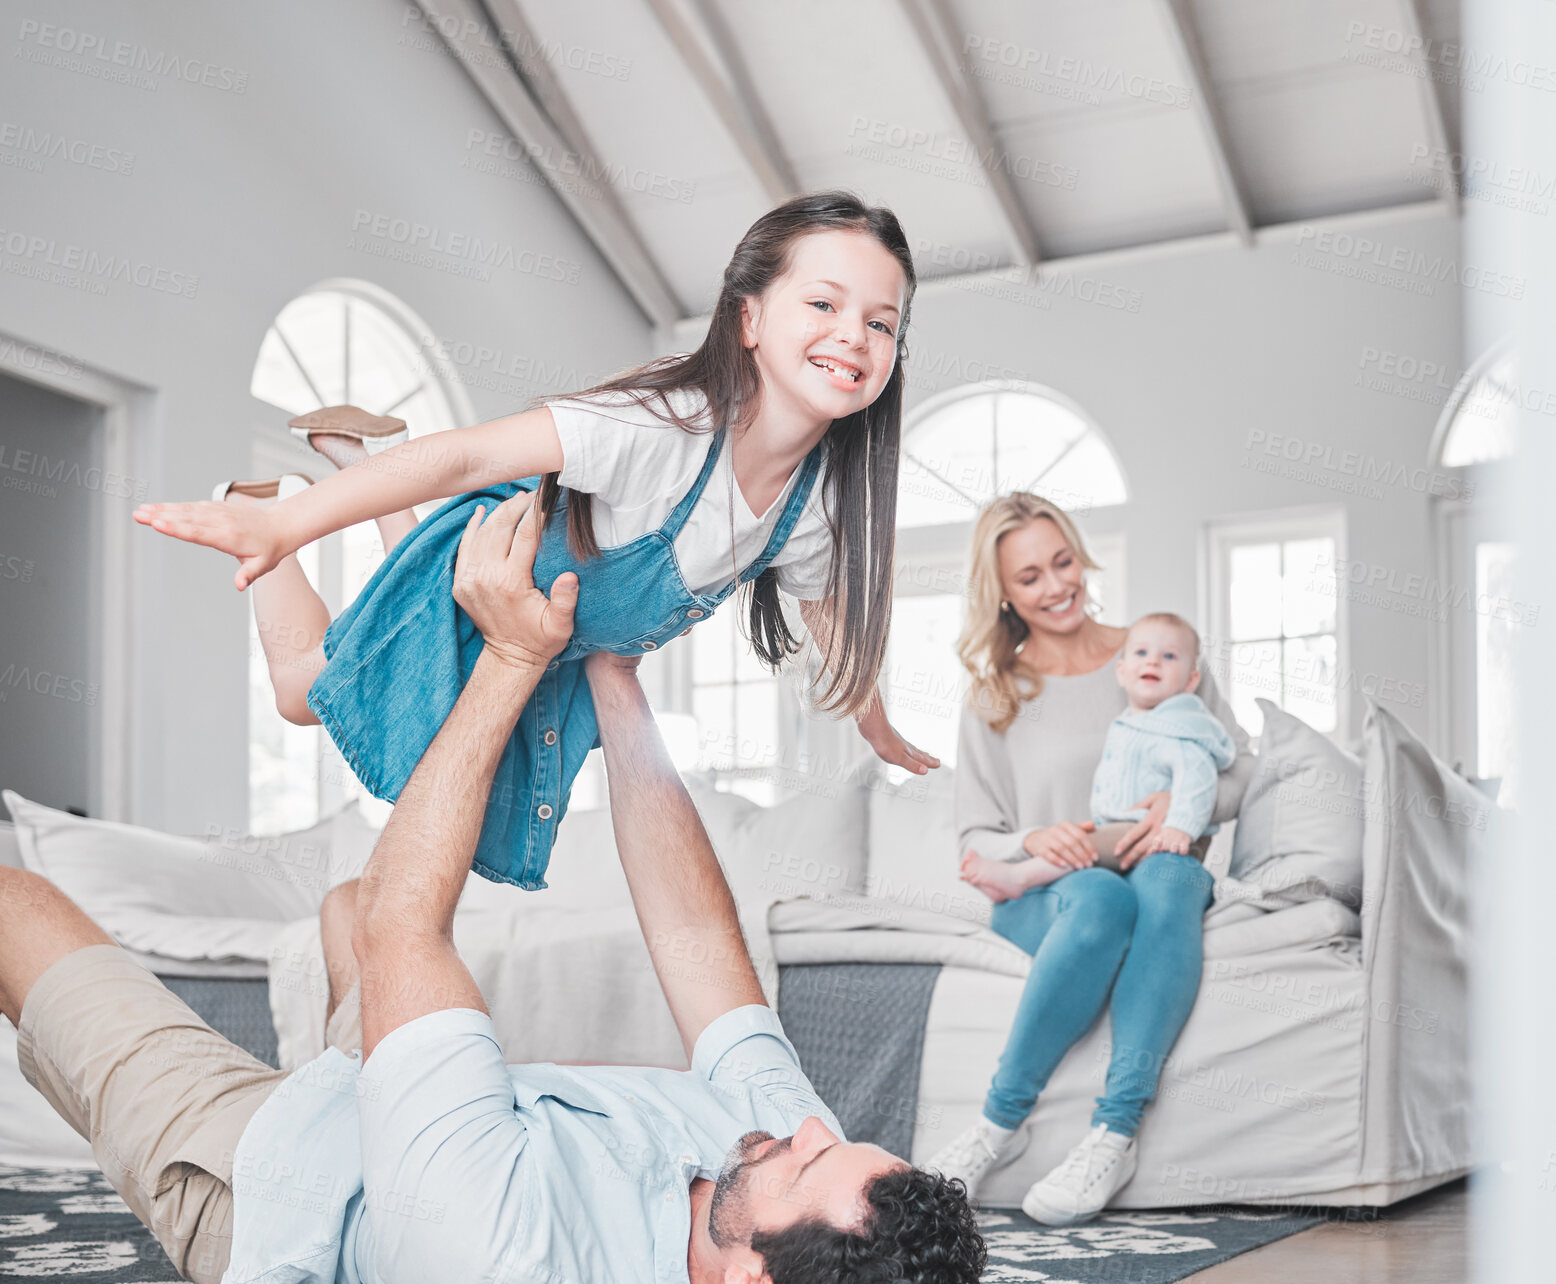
[{"x1": 17, "y1": 945, "x2": 363, "y2": 1284}]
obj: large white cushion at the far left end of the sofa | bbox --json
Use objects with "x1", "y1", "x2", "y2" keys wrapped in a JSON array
[{"x1": 3, "y1": 789, "x2": 375, "y2": 976}]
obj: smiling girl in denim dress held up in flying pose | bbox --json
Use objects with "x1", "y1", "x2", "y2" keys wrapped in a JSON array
[{"x1": 135, "y1": 191, "x2": 938, "y2": 890}]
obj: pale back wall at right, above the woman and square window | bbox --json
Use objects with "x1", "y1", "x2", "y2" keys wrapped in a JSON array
[{"x1": 907, "y1": 205, "x2": 1461, "y2": 750}]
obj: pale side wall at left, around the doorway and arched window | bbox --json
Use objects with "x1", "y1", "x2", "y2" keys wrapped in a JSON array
[{"x1": 0, "y1": 0, "x2": 650, "y2": 831}]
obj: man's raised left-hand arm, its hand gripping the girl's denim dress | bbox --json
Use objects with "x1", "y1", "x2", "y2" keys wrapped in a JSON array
[{"x1": 352, "y1": 493, "x2": 577, "y2": 1060}]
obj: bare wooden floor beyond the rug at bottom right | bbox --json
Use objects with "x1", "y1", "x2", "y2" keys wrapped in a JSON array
[{"x1": 1187, "y1": 1181, "x2": 1469, "y2": 1284}]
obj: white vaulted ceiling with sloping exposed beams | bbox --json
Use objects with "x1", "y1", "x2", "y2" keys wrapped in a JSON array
[{"x1": 422, "y1": 0, "x2": 1456, "y2": 324}]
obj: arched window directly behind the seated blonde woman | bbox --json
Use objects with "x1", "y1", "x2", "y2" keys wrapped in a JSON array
[{"x1": 884, "y1": 381, "x2": 1128, "y2": 766}]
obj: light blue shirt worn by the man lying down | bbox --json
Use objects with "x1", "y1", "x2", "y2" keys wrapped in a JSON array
[{"x1": 223, "y1": 1004, "x2": 842, "y2": 1284}]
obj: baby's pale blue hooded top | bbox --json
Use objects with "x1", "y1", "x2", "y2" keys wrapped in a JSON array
[{"x1": 1091, "y1": 691, "x2": 1237, "y2": 839}]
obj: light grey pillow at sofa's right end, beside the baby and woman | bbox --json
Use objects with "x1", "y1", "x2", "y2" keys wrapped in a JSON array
[{"x1": 1228, "y1": 699, "x2": 1366, "y2": 909}]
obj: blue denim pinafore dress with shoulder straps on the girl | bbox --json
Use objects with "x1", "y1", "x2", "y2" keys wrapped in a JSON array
[{"x1": 308, "y1": 428, "x2": 822, "y2": 892}]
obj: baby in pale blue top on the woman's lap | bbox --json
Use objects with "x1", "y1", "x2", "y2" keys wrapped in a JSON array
[{"x1": 962, "y1": 613, "x2": 1237, "y2": 901}]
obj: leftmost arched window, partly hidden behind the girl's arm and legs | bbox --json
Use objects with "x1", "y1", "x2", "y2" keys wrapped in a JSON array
[{"x1": 249, "y1": 280, "x2": 475, "y2": 833}]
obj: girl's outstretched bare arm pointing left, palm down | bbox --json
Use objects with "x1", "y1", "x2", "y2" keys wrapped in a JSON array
[{"x1": 134, "y1": 406, "x2": 562, "y2": 590}]
